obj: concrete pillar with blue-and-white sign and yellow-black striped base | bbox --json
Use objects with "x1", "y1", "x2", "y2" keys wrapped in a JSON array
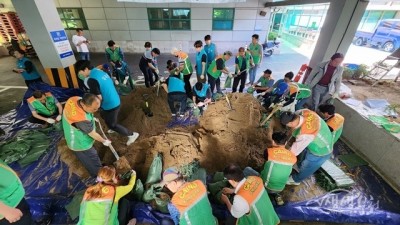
[{"x1": 12, "y1": 0, "x2": 78, "y2": 88}]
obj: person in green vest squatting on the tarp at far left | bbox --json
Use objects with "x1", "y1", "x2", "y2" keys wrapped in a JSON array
[{"x1": 27, "y1": 90, "x2": 62, "y2": 126}]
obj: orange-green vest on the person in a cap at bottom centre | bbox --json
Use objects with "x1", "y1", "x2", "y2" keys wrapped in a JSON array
[{"x1": 171, "y1": 180, "x2": 217, "y2": 225}]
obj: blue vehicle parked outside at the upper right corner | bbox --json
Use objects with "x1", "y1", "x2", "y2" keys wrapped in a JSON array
[{"x1": 353, "y1": 19, "x2": 400, "y2": 52}]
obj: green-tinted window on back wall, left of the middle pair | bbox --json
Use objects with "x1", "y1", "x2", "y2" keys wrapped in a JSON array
[{"x1": 147, "y1": 8, "x2": 190, "y2": 30}]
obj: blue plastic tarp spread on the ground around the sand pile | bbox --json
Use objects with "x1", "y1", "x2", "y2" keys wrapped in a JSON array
[{"x1": 0, "y1": 85, "x2": 400, "y2": 225}]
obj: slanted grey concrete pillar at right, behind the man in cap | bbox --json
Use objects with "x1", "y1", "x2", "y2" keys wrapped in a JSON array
[{"x1": 309, "y1": 0, "x2": 368, "y2": 68}]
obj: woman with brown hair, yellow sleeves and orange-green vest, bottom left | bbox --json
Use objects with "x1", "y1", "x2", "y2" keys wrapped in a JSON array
[{"x1": 78, "y1": 166, "x2": 136, "y2": 225}]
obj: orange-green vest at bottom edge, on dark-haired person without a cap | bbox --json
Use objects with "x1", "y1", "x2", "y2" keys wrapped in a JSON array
[{"x1": 236, "y1": 176, "x2": 279, "y2": 225}]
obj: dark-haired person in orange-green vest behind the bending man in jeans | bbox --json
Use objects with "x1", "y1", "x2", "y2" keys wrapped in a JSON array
[{"x1": 318, "y1": 104, "x2": 344, "y2": 144}]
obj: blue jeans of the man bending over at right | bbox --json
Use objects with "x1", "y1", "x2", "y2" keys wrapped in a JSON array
[{"x1": 292, "y1": 148, "x2": 331, "y2": 182}]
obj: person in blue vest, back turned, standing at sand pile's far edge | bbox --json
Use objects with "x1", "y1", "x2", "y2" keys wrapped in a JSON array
[{"x1": 163, "y1": 62, "x2": 187, "y2": 117}]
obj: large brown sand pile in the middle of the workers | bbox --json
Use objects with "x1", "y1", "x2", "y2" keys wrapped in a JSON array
[{"x1": 59, "y1": 88, "x2": 282, "y2": 178}]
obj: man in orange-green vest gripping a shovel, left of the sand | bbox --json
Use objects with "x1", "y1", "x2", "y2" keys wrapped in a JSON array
[{"x1": 62, "y1": 93, "x2": 111, "y2": 177}]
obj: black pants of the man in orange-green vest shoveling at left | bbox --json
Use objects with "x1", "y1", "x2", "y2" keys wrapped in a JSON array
[{"x1": 74, "y1": 147, "x2": 101, "y2": 177}]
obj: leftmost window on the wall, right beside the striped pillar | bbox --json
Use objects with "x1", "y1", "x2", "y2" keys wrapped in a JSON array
[{"x1": 57, "y1": 8, "x2": 88, "y2": 30}]
